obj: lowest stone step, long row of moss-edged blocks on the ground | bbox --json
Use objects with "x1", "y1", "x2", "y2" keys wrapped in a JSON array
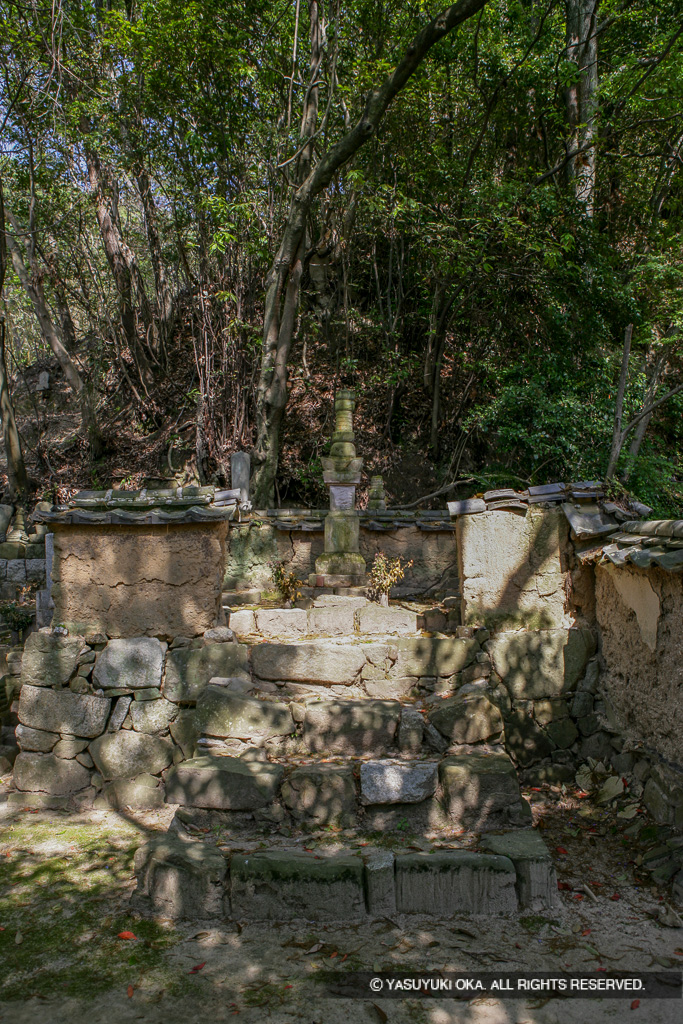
[{"x1": 134, "y1": 829, "x2": 557, "y2": 923}]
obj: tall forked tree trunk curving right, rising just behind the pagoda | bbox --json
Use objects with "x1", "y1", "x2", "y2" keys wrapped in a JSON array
[{"x1": 248, "y1": 0, "x2": 486, "y2": 507}]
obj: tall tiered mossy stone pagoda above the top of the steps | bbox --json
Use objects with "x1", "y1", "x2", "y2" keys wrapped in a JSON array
[{"x1": 309, "y1": 390, "x2": 366, "y2": 587}]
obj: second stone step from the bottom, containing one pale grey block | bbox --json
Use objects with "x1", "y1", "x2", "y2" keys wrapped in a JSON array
[{"x1": 165, "y1": 750, "x2": 529, "y2": 830}]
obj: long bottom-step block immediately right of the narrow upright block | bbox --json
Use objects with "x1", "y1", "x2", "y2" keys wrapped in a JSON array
[{"x1": 395, "y1": 850, "x2": 517, "y2": 918}]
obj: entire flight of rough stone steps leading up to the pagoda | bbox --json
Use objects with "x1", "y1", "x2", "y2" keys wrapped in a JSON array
[{"x1": 135, "y1": 595, "x2": 556, "y2": 921}]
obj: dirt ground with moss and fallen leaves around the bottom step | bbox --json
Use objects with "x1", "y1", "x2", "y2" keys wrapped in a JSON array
[{"x1": 0, "y1": 791, "x2": 683, "y2": 1024}]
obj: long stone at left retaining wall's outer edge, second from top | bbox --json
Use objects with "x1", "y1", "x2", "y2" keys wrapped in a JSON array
[{"x1": 18, "y1": 685, "x2": 112, "y2": 738}]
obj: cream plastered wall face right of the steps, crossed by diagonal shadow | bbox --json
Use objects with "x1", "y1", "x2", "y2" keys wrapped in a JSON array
[{"x1": 456, "y1": 509, "x2": 568, "y2": 629}]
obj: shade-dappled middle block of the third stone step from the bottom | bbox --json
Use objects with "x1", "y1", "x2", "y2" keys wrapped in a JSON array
[{"x1": 303, "y1": 700, "x2": 400, "y2": 755}]
